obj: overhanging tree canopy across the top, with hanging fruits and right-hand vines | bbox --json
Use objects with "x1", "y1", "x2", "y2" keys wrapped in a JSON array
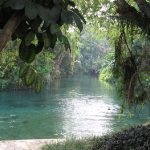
[{"x1": 0, "y1": 0, "x2": 150, "y2": 99}]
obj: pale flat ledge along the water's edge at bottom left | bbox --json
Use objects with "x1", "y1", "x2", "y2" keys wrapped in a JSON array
[{"x1": 0, "y1": 139, "x2": 65, "y2": 150}]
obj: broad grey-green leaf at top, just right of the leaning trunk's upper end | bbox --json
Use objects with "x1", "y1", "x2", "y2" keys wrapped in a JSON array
[{"x1": 25, "y1": 1, "x2": 38, "y2": 19}]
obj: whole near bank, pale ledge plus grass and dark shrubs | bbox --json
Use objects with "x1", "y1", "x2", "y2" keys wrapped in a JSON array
[{"x1": 0, "y1": 123, "x2": 150, "y2": 150}]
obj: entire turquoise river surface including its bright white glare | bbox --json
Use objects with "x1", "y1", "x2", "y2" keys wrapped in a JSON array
[{"x1": 0, "y1": 76, "x2": 150, "y2": 140}]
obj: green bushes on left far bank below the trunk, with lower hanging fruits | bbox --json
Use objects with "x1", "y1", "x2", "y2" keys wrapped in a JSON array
[{"x1": 0, "y1": 41, "x2": 54, "y2": 90}]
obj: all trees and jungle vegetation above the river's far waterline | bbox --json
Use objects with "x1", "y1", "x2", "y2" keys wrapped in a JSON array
[{"x1": 0, "y1": 0, "x2": 150, "y2": 104}]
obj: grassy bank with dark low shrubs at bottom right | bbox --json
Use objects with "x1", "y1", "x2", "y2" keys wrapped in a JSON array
[{"x1": 42, "y1": 123, "x2": 150, "y2": 150}]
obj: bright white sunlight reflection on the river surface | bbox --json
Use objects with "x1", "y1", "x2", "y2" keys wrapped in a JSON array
[{"x1": 63, "y1": 96, "x2": 119, "y2": 137}]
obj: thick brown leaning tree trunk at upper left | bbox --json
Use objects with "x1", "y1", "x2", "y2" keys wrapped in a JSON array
[{"x1": 0, "y1": 12, "x2": 22, "y2": 52}]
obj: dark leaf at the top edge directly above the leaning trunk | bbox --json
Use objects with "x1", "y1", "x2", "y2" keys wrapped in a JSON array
[{"x1": 6, "y1": 0, "x2": 25, "y2": 10}]
